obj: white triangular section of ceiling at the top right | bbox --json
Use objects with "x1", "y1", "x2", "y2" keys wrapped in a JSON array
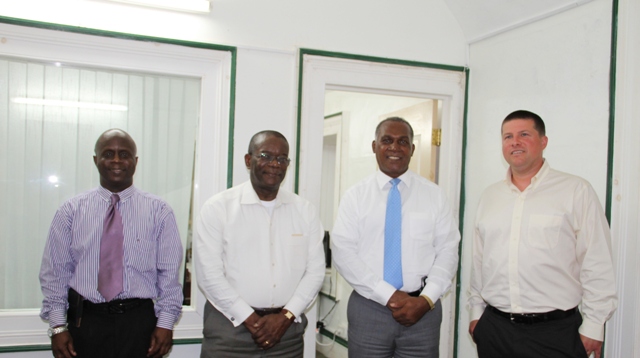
[{"x1": 443, "y1": 0, "x2": 593, "y2": 43}]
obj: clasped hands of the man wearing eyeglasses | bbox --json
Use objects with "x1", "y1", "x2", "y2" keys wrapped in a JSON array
[{"x1": 243, "y1": 312, "x2": 292, "y2": 350}]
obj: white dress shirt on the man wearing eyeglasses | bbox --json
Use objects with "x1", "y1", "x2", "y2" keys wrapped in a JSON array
[{"x1": 194, "y1": 182, "x2": 325, "y2": 327}]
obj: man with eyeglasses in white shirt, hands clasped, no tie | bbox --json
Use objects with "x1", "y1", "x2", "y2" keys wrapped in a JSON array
[{"x1": 194, "y1": 131, "x2": 325, "y2": 358}]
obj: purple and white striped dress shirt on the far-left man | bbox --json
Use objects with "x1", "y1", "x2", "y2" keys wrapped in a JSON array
[{"x1": 40, "y1": 186, "x2": 183, "y2": 329}]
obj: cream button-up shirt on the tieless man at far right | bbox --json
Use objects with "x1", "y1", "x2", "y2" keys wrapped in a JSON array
[{"x1": 469, "y1": 160, "x2": 617, "y2": 341}]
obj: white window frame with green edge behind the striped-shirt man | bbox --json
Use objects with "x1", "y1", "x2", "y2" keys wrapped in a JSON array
[{"x1": 0, "y1": 17, "x2": 237, "y2": 353}]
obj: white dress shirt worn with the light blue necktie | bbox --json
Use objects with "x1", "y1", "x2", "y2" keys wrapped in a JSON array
[{"x1": 331, "y1": 171, "x2": 460, "y2": 305}]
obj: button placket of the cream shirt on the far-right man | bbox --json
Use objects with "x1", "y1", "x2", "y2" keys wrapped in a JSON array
[{"x1": 509, "y1": 193, "x2": 527, "y2": 312}]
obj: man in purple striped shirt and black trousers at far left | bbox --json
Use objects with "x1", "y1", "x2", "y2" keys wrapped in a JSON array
[{"x1": 40, "y1": 129, "x2": 183, "y2": 358}]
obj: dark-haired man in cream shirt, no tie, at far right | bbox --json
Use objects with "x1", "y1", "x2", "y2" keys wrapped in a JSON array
[{"x1": 469, "y1": 110, "x2": 617, "y2": 358}]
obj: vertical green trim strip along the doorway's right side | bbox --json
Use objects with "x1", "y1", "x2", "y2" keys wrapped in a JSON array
[{"x1": 453, "y1": 68, "x2": 470, "y2": 358}]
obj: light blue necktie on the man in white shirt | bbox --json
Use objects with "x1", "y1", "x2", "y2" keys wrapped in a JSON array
[{"x1": 384, "y1": 178, "x2": 402, "y2": 289}]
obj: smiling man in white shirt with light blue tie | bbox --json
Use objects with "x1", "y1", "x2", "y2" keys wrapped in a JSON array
[{"x1": 331, "y1": 117, "x2": 460, "y2": 358}]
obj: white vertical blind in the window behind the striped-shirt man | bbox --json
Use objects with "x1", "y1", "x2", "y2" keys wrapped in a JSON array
[{"x1": 0, "y1": 57, "x2": 201, "y2": 309}]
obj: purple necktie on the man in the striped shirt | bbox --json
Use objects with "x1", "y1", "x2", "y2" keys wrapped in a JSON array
[{"x1": 98, "y1": 194, "x2": 124, "y2": 302}]
